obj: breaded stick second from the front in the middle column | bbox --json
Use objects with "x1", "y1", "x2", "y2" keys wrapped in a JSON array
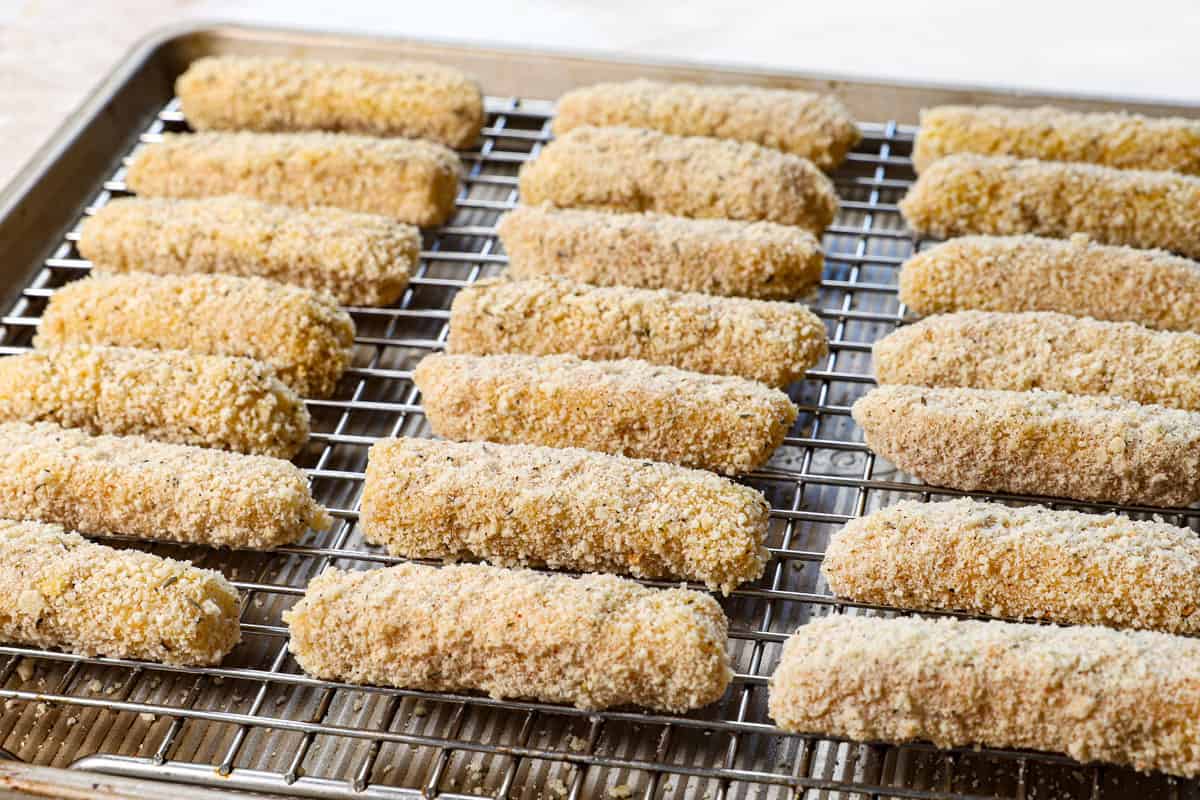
[{"x1": 360, "y1": 438, "x2": 770, "y2": 594}]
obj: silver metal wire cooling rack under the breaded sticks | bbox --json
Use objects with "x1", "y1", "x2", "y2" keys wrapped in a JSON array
[{"x1": 0, "y1": 98, "x2": 1200, "y2": 800}]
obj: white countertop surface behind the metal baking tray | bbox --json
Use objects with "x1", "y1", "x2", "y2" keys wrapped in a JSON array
[{"x1": 0, "y1": 0, "x2": 1200, "y2": 185}]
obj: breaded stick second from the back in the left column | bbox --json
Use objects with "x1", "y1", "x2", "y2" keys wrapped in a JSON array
[{"x1": 125, "y1": 132, "x2": 462, "y2": 225}]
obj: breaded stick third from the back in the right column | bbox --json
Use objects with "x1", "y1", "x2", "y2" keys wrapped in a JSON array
[{"x1": 900, "y1": 234, "x2": 1200, "y2": 331}]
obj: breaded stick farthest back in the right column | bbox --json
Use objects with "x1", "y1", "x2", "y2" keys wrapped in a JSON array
[{"x1": 912, "y1": 106, "x2": 1200, "y2": 175}]
